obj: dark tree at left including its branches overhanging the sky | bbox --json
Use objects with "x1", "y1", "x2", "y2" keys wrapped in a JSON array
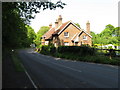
[{"x1": 2, "y1": 1, "x2": 65, "y2": 48}]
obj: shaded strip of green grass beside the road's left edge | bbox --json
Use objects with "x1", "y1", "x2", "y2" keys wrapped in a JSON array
[{"x1": 11, "y1": 52, "x2": 24, "y2": 72}]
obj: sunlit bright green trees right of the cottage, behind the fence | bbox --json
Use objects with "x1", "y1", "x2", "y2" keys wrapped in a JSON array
[{"x1": 91, "y1": 24, "x2": 120, "y2": 45}]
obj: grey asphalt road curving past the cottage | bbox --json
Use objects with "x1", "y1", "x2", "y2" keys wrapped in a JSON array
[{"x1": 19, "y1": 49, "x2": 118, "y2": 88}]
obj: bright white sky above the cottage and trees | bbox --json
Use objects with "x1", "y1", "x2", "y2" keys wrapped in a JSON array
[{"x1": 31, "y1": 0, "x2": 120, "y2": 33}]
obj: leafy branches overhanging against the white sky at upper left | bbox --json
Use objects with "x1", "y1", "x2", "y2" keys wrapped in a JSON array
[{"x1": 15, "y1": 0, "x2": 66, "y2": 23}]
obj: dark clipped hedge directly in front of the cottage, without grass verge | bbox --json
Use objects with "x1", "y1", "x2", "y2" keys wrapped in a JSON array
[{"x1": 40, "y1": 46, "x2": 96, "y2": 56}]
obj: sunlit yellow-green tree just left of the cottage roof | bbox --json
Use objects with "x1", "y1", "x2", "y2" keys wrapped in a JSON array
[{"x1": 34, "y1": 26, "x2": 50, "y2": 46}]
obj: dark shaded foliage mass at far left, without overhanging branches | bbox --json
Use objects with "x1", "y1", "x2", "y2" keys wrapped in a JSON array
[{"x1": 2, "y1": 3, "x2": 27, "y2": 48}]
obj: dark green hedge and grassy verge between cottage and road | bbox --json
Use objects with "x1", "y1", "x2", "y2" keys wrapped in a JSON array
[{"x1": 40, "y1": 46, "x2": 120, "y2": 65}]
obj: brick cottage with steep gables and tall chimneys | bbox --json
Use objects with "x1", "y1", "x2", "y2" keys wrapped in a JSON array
[{"x1": 41, "y1": 15, "x2": 92, "y2": 47}]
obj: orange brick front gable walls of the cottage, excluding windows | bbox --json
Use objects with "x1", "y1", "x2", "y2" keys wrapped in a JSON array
[{"x1": 58, "y1": 24, "x2": 91, "y2": 46}]
